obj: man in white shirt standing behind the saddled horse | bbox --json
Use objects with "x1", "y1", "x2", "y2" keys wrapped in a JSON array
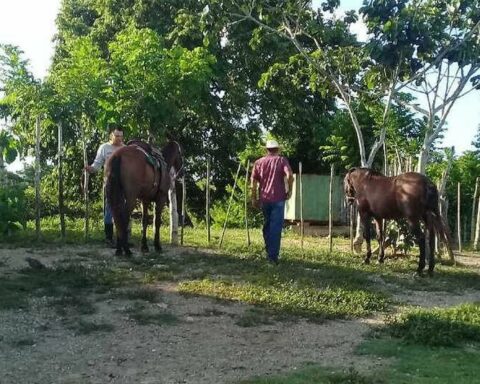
[{"x1": 85, "y1": 127, "x2": 125, "y2": 246}]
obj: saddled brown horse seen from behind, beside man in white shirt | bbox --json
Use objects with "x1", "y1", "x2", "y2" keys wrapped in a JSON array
[{"x1": 105, "y1": 141, "x2": 183, "y2": 256}]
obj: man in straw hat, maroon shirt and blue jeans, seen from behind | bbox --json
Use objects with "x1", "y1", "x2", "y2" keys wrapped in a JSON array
[{"x1": 251, "y1": 140, "x2": 293, "y2": 264}]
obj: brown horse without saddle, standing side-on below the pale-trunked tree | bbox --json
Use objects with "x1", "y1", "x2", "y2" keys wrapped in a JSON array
[{"x1": 344, "y1": 168, "x2": 449, "y2": 275}]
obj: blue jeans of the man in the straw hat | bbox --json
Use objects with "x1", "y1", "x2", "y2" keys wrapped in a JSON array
[{"x1": 262, "y1": 200, "x2": 285, "y2": 262}]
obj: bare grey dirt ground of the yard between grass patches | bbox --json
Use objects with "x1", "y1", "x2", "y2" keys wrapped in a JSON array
[{"x1": 0, "y1": 247, "x2": 480, "y2": 384}]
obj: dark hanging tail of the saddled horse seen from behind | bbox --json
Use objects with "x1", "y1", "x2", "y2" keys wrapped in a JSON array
[{"x1": 105, "y1": 154, "x2": 126, "y2": 243}]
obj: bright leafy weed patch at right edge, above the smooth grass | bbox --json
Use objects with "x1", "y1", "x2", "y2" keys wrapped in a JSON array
[{"x1": 384, "y1": 303, "x2": 480, "y2": 346}]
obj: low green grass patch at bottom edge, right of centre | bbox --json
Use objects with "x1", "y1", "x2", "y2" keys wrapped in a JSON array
[{"x1": 240, "y1": 366, "x2": 380, "y2": 384}]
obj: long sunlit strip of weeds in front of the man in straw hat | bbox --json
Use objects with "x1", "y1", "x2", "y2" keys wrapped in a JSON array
[{"x1": 179, "y1": 279, "x2": 388, "y2": 321}]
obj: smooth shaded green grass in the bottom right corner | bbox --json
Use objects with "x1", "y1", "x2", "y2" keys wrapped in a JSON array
[{"x1": 356, "y1": 337, "x2": 480, "y2": 384}]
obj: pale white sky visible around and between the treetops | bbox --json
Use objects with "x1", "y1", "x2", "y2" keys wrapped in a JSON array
[{"x1": 0, "y1": 0, "x2": 480, "y2": 171}]
